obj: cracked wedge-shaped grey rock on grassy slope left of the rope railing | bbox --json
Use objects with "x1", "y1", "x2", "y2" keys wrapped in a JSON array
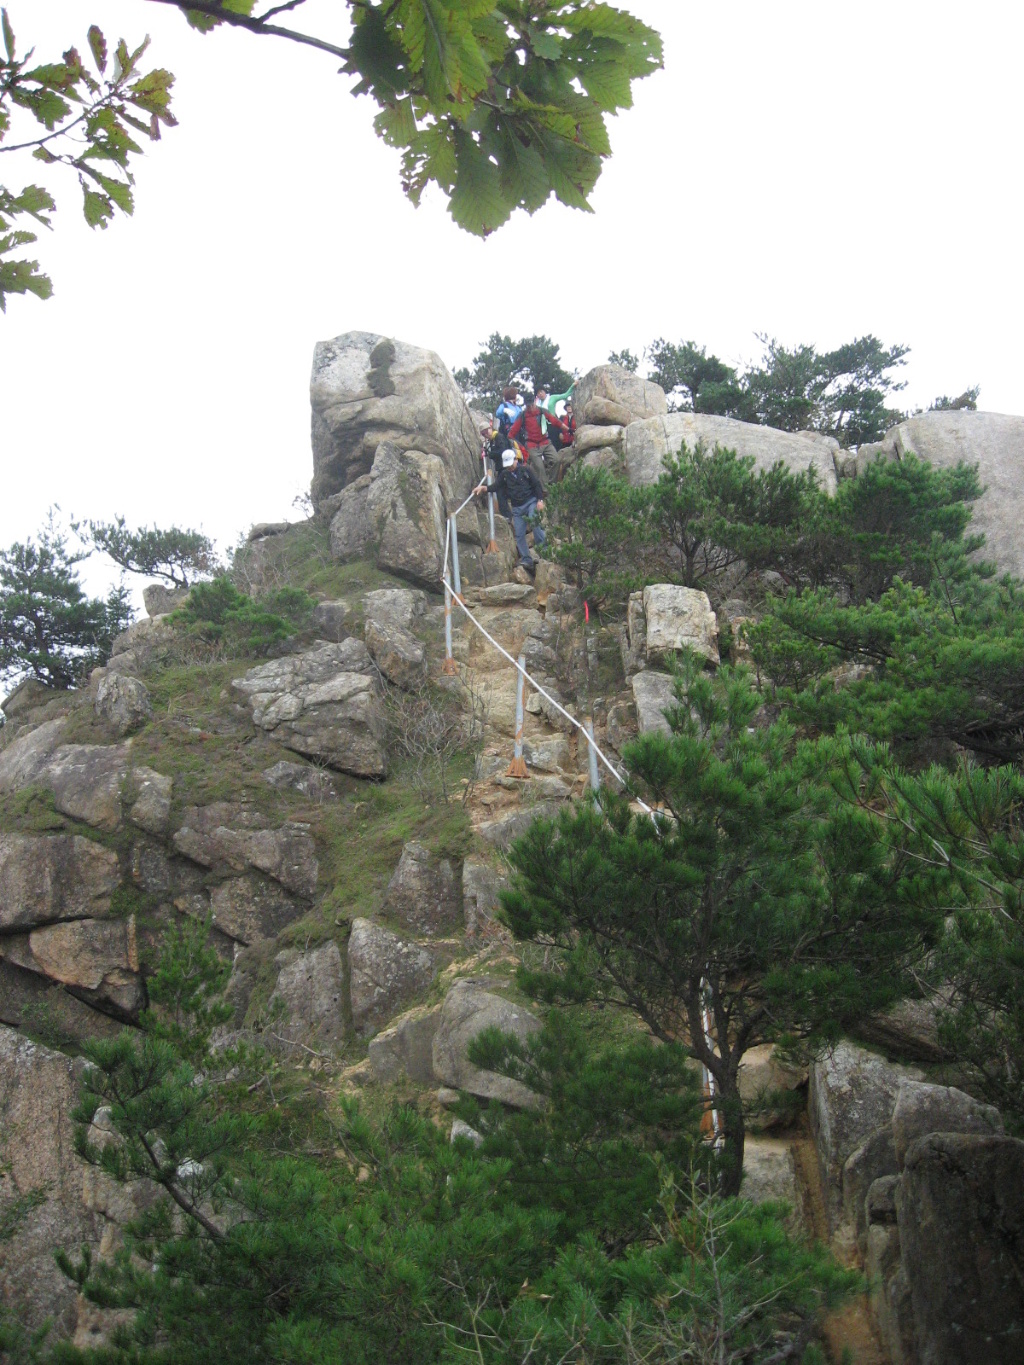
[{"x1": 232, "y1": 640, "x2": 386, "y2": 777}]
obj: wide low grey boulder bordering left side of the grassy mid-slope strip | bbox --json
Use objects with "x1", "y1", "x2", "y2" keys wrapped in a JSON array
[{"x1": 173, "y1": 801, "x2": 319, "y2": 900}]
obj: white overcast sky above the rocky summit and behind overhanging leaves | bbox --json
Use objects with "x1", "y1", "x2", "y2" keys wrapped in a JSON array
[{"x1": 0, "y1": 0, "x2": 1024, "y2": 592}]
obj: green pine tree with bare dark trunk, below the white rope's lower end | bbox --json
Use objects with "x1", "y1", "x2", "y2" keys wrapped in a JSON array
[{"x1": 502, "y1": 658, "x2": 941, "y2": 1193}]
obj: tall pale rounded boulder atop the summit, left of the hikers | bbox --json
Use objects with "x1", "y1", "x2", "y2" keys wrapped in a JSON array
[{"x1": 310, "y1": 332, "x2": 479, "y2": 511}]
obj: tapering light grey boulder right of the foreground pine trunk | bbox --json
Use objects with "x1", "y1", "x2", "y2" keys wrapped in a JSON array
[{"x1": 808, "y1": 1041, "x2": 920, "y2": 1231}]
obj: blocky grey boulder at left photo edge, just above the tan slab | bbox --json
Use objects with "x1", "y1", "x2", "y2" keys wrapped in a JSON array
[{"x1": 0, "y1": 834, "x2": 120, "y2": 934}]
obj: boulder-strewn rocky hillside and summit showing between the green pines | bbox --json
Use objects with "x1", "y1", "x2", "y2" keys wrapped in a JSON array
[{"x1": 0, "y1": 332, "x2": 1024, "y2": 1365}]
